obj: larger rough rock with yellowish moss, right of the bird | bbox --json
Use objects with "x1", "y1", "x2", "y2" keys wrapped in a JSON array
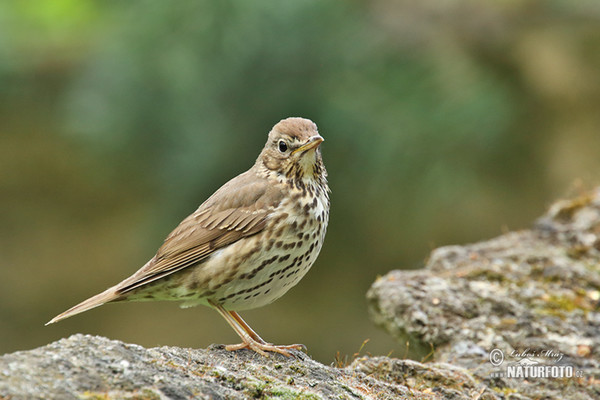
[{"x1": 367, "y1": 189, "x2": 600, "y2": 399}]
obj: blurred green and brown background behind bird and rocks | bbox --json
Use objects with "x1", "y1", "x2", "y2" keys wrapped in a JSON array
[{"x1": 0, "y1": 0, "x2": 600, "y2": 363}]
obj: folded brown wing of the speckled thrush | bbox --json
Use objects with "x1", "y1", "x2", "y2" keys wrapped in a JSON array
[{"x1": 117, "y1": 171, "x2": 282, "y2": 294}]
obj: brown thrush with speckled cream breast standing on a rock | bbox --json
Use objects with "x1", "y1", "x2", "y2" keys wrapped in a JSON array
[{"x1": 46, "y1": 117, "x2": 330, "y2": 356}]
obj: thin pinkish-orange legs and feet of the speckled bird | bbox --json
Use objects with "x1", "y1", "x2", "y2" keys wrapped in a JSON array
[{"x1": 210, "y1": 302, "x2": 305, "y2": 357}]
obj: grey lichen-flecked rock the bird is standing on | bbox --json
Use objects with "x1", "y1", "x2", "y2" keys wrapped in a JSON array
[{"x1": 0, "y1": 334, "x2": 496, "y2": 400}]
